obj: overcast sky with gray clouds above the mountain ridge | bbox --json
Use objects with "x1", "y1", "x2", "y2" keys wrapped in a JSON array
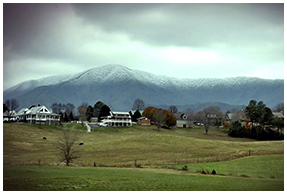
[{"x1": 3, "y1": 3, "x2": 284, "y2": 90}]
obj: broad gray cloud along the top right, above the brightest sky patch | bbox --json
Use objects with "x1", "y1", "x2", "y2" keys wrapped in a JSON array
[{"x1": 73, "y1": 4, "x2": 284, "y2": 47}]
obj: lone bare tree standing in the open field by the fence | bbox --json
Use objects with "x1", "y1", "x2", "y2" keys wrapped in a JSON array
[{"x1": 57, "y1": 130, "x2": 80, "y2": 166}]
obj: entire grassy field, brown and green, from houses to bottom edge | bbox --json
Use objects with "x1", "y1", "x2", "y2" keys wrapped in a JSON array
[{"x1": 3, "y1": 123, "x2": 284, "y2": 190}]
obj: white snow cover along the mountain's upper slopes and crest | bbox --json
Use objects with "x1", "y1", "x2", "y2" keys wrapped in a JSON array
[{"x1": 5, "y1": 65, "x2": 282, "y2": 92}]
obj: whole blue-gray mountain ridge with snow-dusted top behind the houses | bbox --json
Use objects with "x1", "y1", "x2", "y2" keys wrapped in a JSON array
[{"x1": 3, "y1": 65, "x2": 284, "y2": 111}]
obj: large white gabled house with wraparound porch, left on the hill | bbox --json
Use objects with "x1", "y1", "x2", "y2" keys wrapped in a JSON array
[{"x1": 16, "y1": 106, "x2": 60, "y2": 125}]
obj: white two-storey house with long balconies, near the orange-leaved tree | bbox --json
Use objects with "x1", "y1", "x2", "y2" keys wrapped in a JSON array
[{"x1": 101, "y1": 111, "x2": 132, "y2": 127}]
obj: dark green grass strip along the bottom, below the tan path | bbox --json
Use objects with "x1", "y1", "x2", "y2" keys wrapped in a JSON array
[{"x1": 3, "y1": 166, "x2": 284, "y2": 191}]
